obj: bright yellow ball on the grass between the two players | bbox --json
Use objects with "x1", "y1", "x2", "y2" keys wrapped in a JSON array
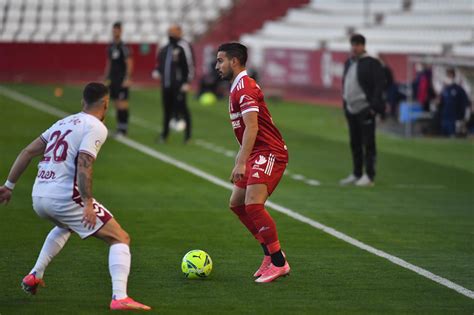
[{"x1": 181, "y1": 249, "x2": 212, "y2": 279}]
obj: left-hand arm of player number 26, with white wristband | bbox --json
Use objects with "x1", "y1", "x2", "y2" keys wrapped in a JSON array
[{"x1": 0, "y1": 137, "x2": 46, "y2": 203}]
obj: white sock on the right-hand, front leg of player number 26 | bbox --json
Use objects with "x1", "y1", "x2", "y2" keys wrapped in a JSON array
[{"x1": 109, "y1": 243, "x2": 132, "y2": 300}]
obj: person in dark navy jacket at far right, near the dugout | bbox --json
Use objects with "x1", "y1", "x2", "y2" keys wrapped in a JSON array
[{"x1": 440, "y1": 68, "x2": 471, "y2": 136}]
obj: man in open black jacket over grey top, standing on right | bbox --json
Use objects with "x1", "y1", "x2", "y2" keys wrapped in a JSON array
[{"x1": 340, "y1": 34, "x2": 385, "y2": 186}]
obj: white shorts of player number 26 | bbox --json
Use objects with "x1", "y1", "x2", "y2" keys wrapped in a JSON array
[{"x1": 33, "y1": 196, "x2": 113, "y2": 239}]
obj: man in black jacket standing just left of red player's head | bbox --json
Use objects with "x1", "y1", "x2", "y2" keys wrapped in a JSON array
[{"x1": 154, "y1": 24, "x2": 193, "y2": 143}]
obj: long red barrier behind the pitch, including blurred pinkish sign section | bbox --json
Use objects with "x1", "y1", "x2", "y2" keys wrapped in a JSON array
[{"x1": 0, "y1": 43, "x2": 408, "y2": 104}]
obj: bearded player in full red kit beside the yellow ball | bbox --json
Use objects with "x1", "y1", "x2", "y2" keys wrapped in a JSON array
[{"x1": 216, "y1": 43, "x2": 290, "y2": 283}]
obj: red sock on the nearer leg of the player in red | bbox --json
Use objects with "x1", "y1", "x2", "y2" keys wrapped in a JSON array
[{"x1": 246, "y1": 204, "x2": 280, "y2": 254}]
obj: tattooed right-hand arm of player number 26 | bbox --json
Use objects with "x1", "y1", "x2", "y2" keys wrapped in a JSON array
[{"x1": 76, "y1": 152, "x2": 96, "y2": 229}]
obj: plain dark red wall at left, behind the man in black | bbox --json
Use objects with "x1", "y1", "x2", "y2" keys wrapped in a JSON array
[{"x1": 0, "y1": 43, "x2": 156, "y2": 84}]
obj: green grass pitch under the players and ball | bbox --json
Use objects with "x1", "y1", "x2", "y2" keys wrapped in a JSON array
[{"x1": 0, "y1": 84, "x2": 474, "y2": 315}]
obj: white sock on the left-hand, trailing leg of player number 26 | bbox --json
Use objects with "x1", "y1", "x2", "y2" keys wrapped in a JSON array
[{"x1": 30, "y1": 226, "x2": 71, "y2": 279}]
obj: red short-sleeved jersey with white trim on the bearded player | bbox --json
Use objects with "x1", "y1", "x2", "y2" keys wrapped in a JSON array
[{"x1": 229, "y1": 71, "x2": 288, "y2": 162}]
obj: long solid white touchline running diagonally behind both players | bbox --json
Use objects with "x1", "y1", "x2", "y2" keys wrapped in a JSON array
[{"x1": 0, "y1": 86, "x2": 474, "y2": 300}]
